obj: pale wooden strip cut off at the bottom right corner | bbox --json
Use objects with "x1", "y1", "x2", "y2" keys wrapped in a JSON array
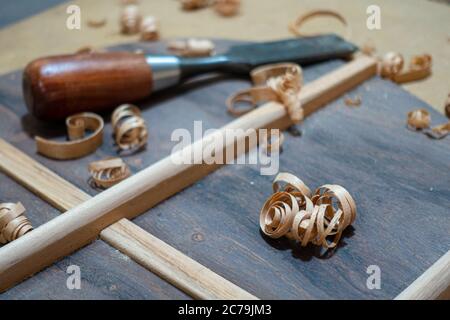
[{"x1": 395, "y1": 250, "x2": 450, "y2": 300}]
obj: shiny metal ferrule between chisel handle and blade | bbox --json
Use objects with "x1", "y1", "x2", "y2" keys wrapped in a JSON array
[{"x1": 146, "y1": 55, "x2": 181, "y2": 91}]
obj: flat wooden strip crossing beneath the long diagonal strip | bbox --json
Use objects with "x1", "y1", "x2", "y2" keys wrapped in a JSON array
[{"x1": 0, "y1": 139, "x2": 257, "y2": 299}]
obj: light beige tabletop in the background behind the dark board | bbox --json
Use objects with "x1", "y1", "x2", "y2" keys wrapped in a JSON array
[{"x1": 0, "y1": 0, "x2": 450, "y2": 112}]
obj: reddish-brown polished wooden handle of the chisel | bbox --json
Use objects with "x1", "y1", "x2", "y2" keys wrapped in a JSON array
[{"x1": 23, "y1": 52, "x2": 153, "y2": 120}]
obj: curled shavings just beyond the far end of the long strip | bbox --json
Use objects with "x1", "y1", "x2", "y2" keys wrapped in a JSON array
[{"x1": 378, "y1": 52, "x2": 432, "y2": 83}]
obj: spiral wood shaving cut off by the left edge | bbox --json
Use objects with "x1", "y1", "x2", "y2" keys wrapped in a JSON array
[{"x1": 0, "y1": 202, "x2": 33, "y2": 244}]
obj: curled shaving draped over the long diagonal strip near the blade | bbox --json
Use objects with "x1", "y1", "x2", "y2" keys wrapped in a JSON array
[{"x1": 227, "y1": 63, "x2": 303, "y2": 123}]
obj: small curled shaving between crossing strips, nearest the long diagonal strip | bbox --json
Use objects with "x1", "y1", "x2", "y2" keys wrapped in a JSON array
[{"x1": 88, "y1": 158, "x2": 131, "y2": 189}]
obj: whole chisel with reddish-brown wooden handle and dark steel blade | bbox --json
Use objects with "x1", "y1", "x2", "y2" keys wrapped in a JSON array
[{"x1": 23, "y1": 34, "x2": 357, "y2": 120}]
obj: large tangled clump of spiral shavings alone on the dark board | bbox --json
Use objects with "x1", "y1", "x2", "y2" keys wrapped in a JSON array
[{"x1": 259, "y1": 172, "x2": 356, "y2": 249}]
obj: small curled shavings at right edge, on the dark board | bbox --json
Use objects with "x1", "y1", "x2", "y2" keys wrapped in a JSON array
[{"x1": 406, "y1": 109, "x2": 450, "y2": 139}]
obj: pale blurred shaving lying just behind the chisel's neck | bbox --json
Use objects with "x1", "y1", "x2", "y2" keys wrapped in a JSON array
[{"x1": 167, "y1": 39, "x2": 215, "y2": 57}]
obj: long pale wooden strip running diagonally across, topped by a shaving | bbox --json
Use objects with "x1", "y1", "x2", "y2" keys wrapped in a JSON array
[{"x1": 0, "y1": 57, "x2": 376, "y2": 290}]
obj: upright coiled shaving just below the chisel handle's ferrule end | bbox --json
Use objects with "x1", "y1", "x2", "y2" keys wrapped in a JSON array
[{"x1": 111, "y1": 104, "x2": 148, "y2": 150}]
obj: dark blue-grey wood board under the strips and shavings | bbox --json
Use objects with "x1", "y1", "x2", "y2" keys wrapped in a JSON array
[{"x1": 0, "y1": 41, "x2": 450, "y2": 299}]
